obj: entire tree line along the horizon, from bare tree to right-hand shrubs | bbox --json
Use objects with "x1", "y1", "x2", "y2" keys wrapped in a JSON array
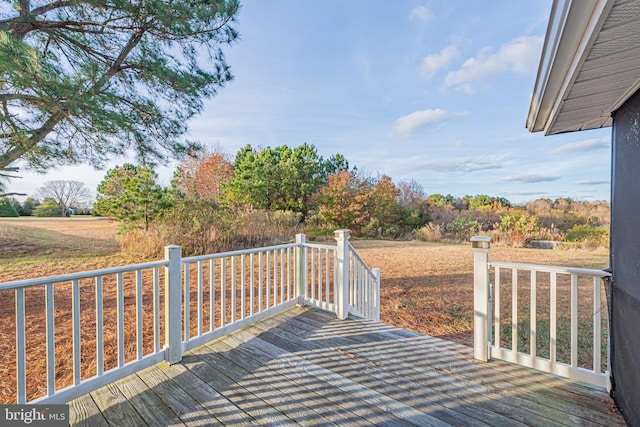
[{"x1": 0, "y1": 143, "x2": 609, "y2": 253}]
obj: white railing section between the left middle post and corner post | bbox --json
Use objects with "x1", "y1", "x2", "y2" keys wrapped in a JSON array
[{"x1": 179, "y1": 243, "x2": 303, "y2": 356}]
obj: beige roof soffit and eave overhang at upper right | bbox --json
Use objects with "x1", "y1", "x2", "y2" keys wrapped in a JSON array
[{"x1": 527, "y1": 0, "x2": 640, "y2": 135}]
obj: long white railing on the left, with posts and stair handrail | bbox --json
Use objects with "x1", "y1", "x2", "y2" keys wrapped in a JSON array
[{"x1": 0, "y1": 230, "x2": 380, "y2": 403}]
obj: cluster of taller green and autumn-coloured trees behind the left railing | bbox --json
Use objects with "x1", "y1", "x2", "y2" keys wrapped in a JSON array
[{"x1": 93, "y1": 143, "x2": 429, "y2": 253}]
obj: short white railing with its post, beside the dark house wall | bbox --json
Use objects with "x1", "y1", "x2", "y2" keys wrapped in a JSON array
[{"x1": 472, "y1": 236, "x2": 611, "y2": 390}]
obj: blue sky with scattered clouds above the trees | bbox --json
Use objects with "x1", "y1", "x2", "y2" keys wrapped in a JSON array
[{"x1": 11, "y1": 0, "x2": 611, "y2": 203}]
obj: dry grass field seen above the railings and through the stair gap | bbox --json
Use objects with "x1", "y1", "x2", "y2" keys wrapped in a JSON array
[{"x1": 0, "y1": 217, "x2": 608, "y2": 343}]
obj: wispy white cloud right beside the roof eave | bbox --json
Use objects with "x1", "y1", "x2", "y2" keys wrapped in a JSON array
[{"x1": 445, "y1": 36, "x2": 543, "y2": 94}]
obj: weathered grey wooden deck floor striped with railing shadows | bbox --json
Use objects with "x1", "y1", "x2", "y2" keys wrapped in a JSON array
[{"x1": 70, "y1": 307, "x2": 624, "y2": 427}]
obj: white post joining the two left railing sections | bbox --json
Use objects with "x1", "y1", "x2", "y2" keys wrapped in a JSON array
[{"x1": 164, "y1": 245, "x2": 182, "y2": 364}]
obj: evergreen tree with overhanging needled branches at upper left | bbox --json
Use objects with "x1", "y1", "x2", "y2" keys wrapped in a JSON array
[{"x1": 0, "y1": 0, "x2": 239, "y2": 170}]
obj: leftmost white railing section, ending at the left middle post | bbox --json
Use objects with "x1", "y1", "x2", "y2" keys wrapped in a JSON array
[{"x1": 0, "y1": 261, "x2": 168, "y2": 403}]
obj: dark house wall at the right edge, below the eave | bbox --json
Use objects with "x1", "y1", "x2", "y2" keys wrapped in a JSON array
[{"x1": 610, "y1": 88, "x2": 640, "y2": 425}]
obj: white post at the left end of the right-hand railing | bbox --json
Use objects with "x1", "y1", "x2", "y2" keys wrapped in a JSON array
[{"x1": 471, "y1": 236, "x2": 491, "y2": 362}]
